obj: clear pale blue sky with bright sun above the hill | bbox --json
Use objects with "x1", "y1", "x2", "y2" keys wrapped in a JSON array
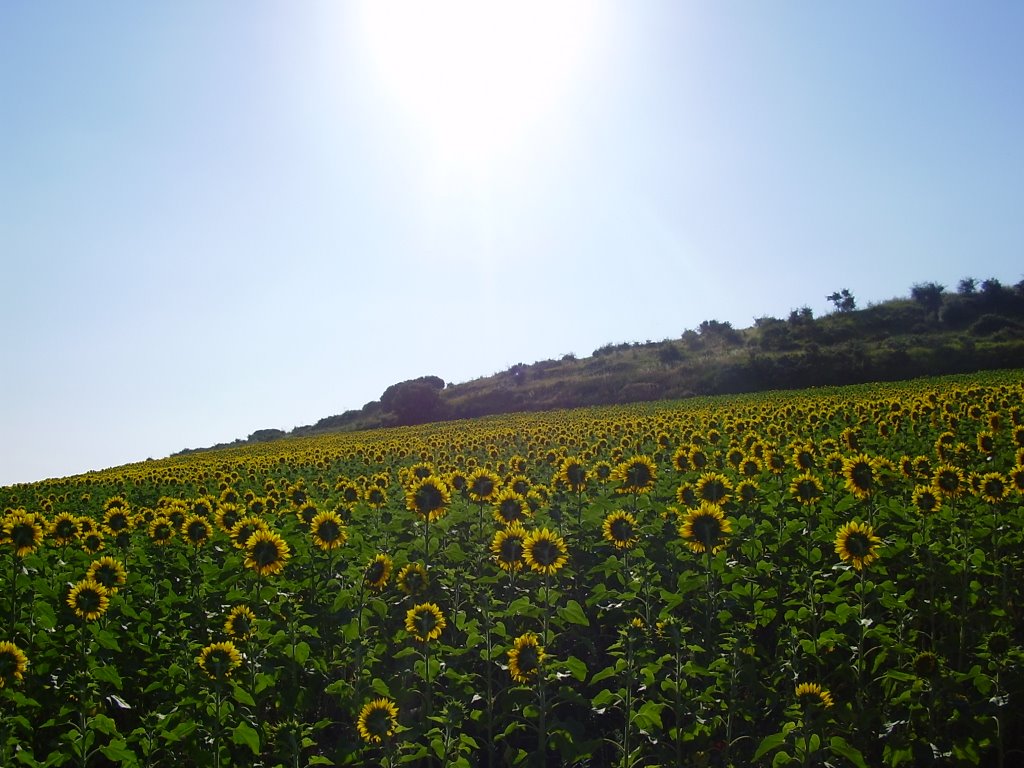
[{"x1": 0, "y1": 0, "x2": 1024, "y2": 485}]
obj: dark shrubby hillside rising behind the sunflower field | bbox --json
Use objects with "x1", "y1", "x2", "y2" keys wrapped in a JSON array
[{"x1": 182, "y1": 280, "x2": 1024, "y2": 453}]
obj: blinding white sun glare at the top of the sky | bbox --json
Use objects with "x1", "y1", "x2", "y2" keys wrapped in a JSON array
[{"x1": 360, "y1": 0, "x2": 599, "y2": 170}]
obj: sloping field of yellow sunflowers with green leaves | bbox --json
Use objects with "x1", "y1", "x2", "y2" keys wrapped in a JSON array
[{"x1": 0, "y1": 372, "x2": 1024, "y2": 768}]
